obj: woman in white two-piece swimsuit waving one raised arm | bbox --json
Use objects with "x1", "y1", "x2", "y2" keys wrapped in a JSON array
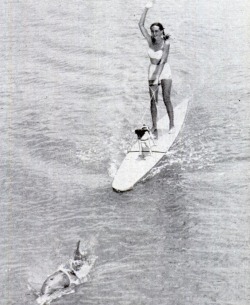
[{"x1": 139, "y1": 0, "x2": 174, "y2": 136}]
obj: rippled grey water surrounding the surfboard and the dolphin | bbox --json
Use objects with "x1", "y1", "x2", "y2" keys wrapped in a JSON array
[{"x1": 0, "y1": 0, "x2": 250, "y2": 305}]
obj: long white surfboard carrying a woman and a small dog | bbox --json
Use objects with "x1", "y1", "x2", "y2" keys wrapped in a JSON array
[{"x1": 112, "y1": 99, "x2": 189, "y2": 192}]
